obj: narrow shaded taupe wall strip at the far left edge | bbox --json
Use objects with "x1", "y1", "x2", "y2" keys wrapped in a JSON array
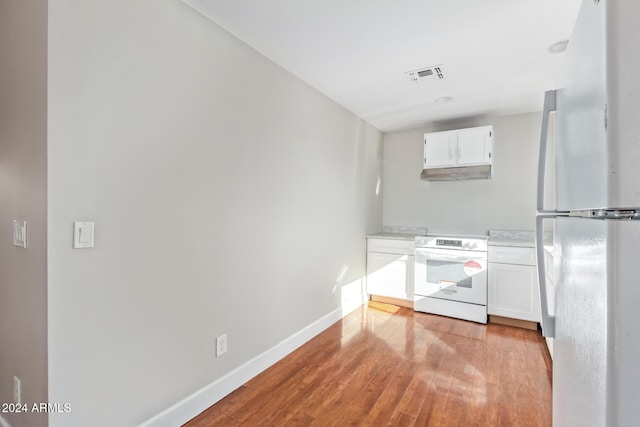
[{"x1": 0, "y1": 0, "x2": 47, "y2": 427}]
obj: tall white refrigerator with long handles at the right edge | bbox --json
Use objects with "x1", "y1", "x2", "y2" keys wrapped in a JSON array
[{"x1": 536, "y1": 0, "x2": 640, "y2": 427}]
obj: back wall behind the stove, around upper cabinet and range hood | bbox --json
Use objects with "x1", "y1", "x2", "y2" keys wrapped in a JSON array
[{"x1": 382, "y1": 113, "x2": 552, "y2": 234}]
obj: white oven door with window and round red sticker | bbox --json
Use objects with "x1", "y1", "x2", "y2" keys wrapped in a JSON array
[{"x1": 415, "y1": 248, "x2": 487, "y2": 305}]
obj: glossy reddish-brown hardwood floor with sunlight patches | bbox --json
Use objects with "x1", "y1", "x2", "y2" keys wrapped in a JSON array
[{"x1": 186, "y1": 302, "x2": 551, "y2": 427}]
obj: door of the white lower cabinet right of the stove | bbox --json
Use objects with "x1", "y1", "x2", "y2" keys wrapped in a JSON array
[{"x1": 487, "y1": 262, "x2": 540, "y2": 322}]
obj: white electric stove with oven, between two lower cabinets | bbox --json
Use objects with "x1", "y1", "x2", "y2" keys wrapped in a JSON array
[{"x1": 413, "y1": 235, "x2": 488, "y2": 323}]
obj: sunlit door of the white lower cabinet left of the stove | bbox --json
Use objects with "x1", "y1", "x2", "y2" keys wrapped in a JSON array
[{"x1": 367, "y1": 252, "x2": 414, "y2": 300}]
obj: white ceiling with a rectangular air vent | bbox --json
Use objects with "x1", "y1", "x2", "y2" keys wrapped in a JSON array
[{"x1": 184, "y1": 0, "x2": 581, "y2": 132}]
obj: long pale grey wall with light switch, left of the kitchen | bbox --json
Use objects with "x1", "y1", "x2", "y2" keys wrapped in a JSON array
[{"x1": 48, "y1": 0, "x2": 382, "y2": 427}]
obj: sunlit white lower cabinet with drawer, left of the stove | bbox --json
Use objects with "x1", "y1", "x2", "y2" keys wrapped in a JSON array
[{"x1": 367, "y1": 239, "x2": 415, "y2": 302}]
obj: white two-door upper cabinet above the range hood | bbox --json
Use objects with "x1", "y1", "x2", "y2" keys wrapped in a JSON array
[{"x1": 424, "y1": 126, "x2": 493, "y2": 169}]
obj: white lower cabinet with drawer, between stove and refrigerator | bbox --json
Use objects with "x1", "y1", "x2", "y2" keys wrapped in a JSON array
[{"x1": 487, "y1": 246, "x2": 540, "y2": 322}]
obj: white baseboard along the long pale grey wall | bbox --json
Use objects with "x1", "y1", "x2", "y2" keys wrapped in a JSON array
[{"x1": 139, "y1": 307, "x2": 342, "y2": 427}]
